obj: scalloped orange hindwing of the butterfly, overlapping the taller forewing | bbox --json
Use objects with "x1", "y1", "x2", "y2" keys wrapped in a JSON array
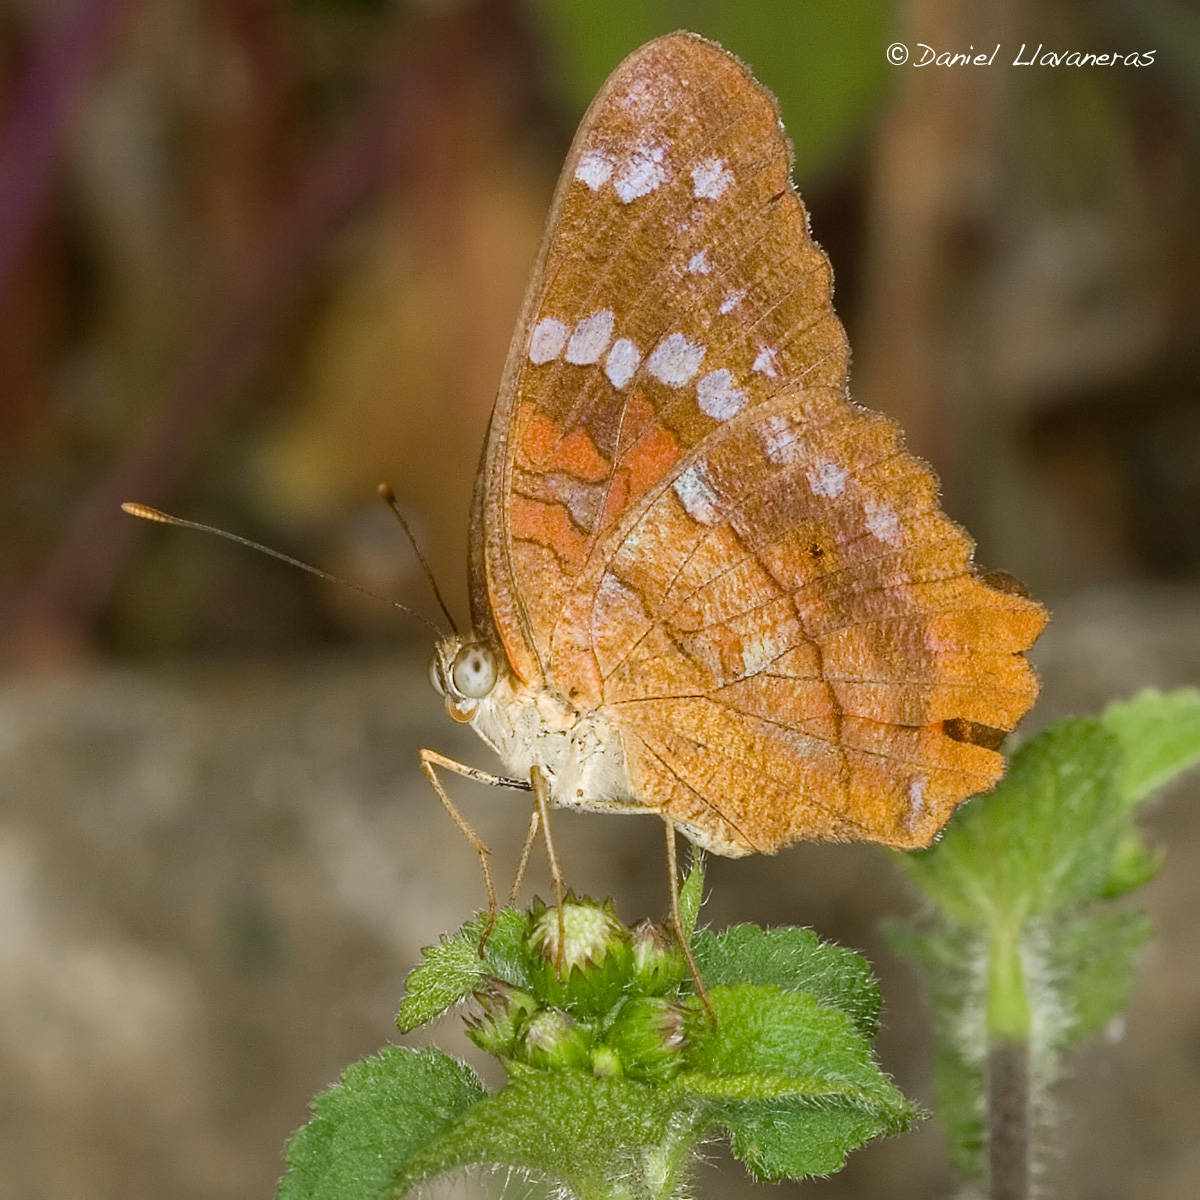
[{"x1": 587, "y1": 390, "x2": 1045, "y2": 852}]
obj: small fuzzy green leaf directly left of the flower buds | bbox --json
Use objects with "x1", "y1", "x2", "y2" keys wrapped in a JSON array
[{"x1": 396, "y1": 908, "x2": 529, "y2": 1033}]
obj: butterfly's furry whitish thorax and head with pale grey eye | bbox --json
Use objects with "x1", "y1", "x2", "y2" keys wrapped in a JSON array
[{"x1": 430, "y1": 636, "x2": 644, "y2": 810}]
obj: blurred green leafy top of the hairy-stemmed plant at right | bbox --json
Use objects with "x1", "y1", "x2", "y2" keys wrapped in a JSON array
[{"x1": 889, "y1": 688, "x2": 1200, "y2": 1180}]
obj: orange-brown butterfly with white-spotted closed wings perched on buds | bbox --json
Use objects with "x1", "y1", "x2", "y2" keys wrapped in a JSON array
[{"x1": 422, "y1": 34, "x2": 1046, "y2": 916}]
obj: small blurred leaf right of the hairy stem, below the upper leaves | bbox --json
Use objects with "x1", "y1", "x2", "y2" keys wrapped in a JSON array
[{"x1": 1051, "y1": 911, "x2": 1153, "y2": 1045}]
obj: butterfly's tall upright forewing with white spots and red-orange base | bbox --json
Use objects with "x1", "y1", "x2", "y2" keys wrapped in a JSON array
[{"x1": 475, "y1": 36, "x2": 846, "y2": 664}]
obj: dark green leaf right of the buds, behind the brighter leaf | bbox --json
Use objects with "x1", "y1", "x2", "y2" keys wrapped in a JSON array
[{"x1": 692, "y1": 925, "x2": 880, "y2": 1039}]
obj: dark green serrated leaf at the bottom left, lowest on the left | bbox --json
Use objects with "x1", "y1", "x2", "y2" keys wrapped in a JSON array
[{"x1": 277, "y1": 1046, "x2": 484, "y2": 1200}]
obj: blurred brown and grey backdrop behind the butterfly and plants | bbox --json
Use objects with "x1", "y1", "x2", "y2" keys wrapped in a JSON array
[{"x1": 0, "y1": 0, "x2": 1200, "y2": 1200}]
